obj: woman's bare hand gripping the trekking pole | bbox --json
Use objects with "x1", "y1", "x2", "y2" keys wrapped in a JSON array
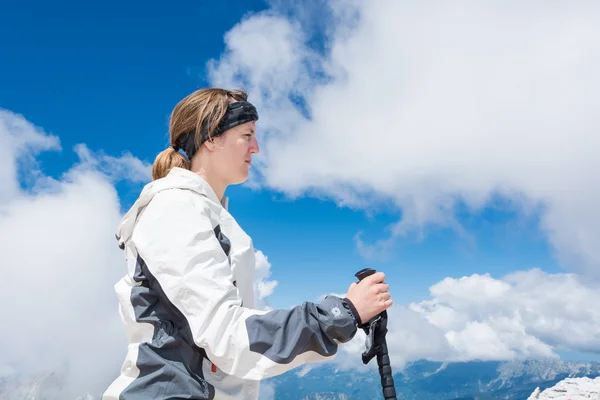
[{"x1": 346, "y1": 272, "x2": 392, "y2": 324}]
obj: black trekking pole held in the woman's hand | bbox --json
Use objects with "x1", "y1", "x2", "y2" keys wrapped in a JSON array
[{"x1": 354, "y1": 268, "x2": 396, "y2": 400}]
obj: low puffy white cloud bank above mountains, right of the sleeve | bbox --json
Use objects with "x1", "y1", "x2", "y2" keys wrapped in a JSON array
[{"x1": 334, "y1": 269, "x2": 600, "y2": 368}]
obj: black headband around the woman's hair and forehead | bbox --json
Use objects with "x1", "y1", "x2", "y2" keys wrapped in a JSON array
[{"x1": 173, "y1": 101, "x2": 258, "y2": 160}]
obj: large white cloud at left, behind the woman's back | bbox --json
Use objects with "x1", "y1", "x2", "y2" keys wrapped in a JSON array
[{"x1": 0, "y1": 111, "x2": 149, "y2": 398}]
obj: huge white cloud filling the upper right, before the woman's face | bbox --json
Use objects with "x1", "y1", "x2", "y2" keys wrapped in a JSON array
[{"x1": 209, "y1": 0, "x2": 600, "y2": 275}]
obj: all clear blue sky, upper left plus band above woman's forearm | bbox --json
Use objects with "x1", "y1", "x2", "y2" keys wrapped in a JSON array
[{"x1": 0, "y1": 1, "x2": 555, "y2": 307}]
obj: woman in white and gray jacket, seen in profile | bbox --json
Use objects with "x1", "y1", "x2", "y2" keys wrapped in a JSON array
[{"x1": 103, "y1": 89, "x2": 392, "y2": 400}]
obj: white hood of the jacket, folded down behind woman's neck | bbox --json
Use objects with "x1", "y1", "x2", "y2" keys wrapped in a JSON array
[{"x1": 115, "y1": 167, "x2": 228, "y2": 249}]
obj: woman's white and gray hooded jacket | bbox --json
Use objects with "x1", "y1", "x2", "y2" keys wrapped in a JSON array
[{"x1": 103, "y1": 168, "x2": 357, "y2": 400}]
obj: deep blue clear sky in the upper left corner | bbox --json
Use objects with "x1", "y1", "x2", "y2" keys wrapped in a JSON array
[{"x1": 0, "y1": 1, "x2": 265, "y2": 173}]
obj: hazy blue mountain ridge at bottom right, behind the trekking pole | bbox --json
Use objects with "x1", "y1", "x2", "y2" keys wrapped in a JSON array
[{"x1": 268, "y1": 360, "x2": 600, "y2": 400}]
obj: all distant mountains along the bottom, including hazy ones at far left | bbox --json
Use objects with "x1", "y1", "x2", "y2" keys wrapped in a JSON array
[{"x1": 0, "y1": 360, "x2": 600, "y2": 400}]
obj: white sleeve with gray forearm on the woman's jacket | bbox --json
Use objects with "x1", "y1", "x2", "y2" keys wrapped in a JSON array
[{"x1": 132, "y1": 189, "x2": 358, "y2": 380}]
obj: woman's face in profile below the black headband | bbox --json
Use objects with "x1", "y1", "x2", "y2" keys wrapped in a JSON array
[{"x1": 207, "y1": 121, "x2": 260, "y2": 185}]
